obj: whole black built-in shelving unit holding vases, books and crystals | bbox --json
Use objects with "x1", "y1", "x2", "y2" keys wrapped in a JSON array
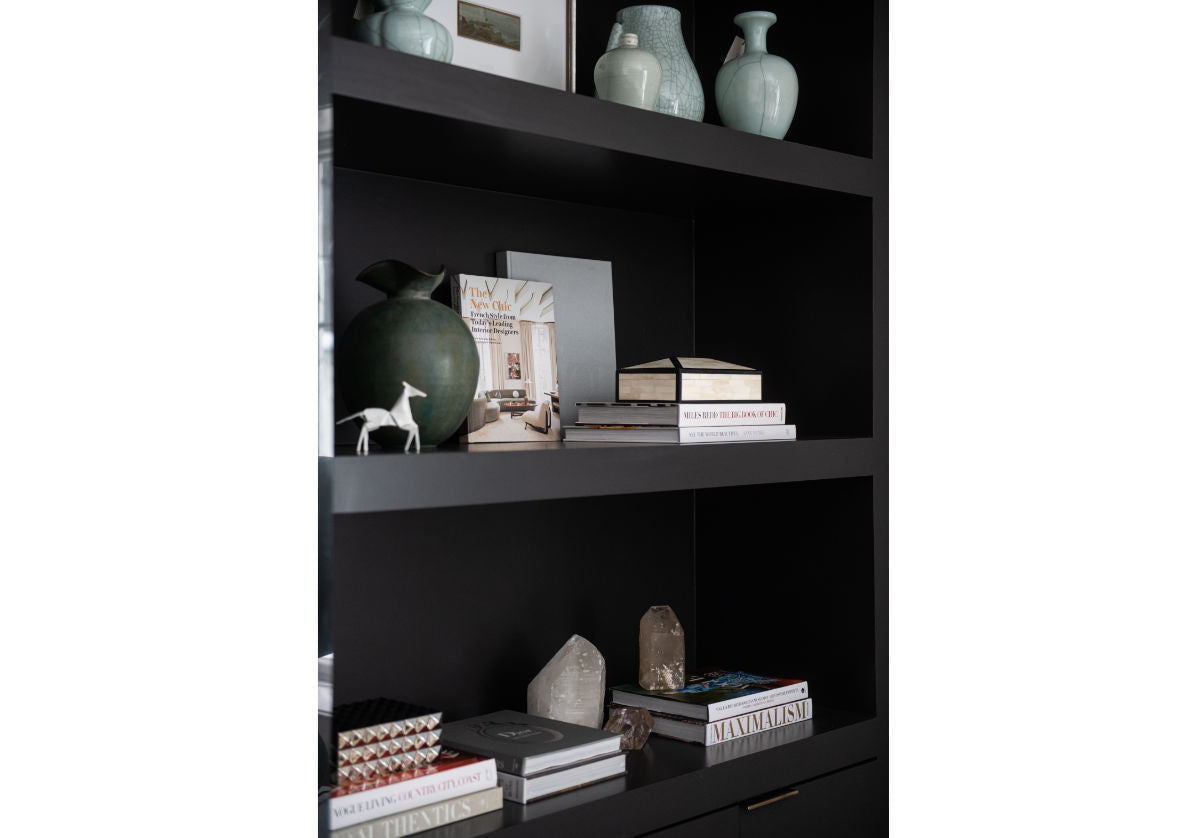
[{"x1": 318, "y1": 0, "x2": 888, "y2": 838}]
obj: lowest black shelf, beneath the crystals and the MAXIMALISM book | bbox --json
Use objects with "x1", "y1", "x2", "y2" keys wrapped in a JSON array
[{"x1": 426, "y1": 702, "x2": 881, "y2": 838}]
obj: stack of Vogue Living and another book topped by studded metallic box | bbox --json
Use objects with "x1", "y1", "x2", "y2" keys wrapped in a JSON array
[{"x1": 329, "y1": 699, "x2": 503, "y2": 838}]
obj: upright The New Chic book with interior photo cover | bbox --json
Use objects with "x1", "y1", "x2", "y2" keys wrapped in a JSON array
[{"x1": 450, "y1": 274, "x2": 563, "y2": 443}]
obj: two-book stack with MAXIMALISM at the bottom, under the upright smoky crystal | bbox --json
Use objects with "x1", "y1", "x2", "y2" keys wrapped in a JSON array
[{"x1": 612, "y1": 670, "x2": 812, "y2": 746}]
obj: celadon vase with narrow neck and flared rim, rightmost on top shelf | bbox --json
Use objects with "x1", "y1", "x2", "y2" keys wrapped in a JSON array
[{"x1": 715, "y1": 12, "x2": 800, "y2": 139}]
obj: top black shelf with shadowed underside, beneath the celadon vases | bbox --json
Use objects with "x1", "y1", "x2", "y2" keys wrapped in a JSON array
[{"x1": 331, "y1": 37, "x2": 878, "y2": 216}]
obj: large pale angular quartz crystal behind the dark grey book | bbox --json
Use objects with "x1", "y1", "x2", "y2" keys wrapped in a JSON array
[{"x1": 527, "y1": 634, "x2": 605, "y2": 728}]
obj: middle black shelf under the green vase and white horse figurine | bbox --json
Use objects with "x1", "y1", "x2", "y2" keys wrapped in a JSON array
[{"x1": 322, "y1": 439, "x2": 878, "y2": 515}]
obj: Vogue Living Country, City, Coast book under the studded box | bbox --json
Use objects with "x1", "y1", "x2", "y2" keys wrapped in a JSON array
[{"x1": 329, "y1": 752, "x2": 497, "y2": 830}]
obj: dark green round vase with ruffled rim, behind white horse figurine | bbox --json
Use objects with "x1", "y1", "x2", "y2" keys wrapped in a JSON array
[{"x1": 335, "y1": 259, "x2": 479, "y2": 448}]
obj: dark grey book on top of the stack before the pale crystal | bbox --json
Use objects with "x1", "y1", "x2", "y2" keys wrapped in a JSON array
[{"x1": 442, "y1": 710, "x2": 620, "y2": 777}]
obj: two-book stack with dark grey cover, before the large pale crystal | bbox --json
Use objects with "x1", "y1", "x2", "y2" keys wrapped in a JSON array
[{"x1": 443, "y1": 711, "x2": 625, "y2": 803}]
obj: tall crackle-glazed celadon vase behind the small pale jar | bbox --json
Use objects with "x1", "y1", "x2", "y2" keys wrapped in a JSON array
[{"x1": 608, "y1": 6, "x2": 704, "y2": 122}]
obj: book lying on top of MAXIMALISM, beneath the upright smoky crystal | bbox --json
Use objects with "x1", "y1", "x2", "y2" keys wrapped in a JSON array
[{"x1": 612, "y1": 670, "x2": 809, "y2": 722}]
